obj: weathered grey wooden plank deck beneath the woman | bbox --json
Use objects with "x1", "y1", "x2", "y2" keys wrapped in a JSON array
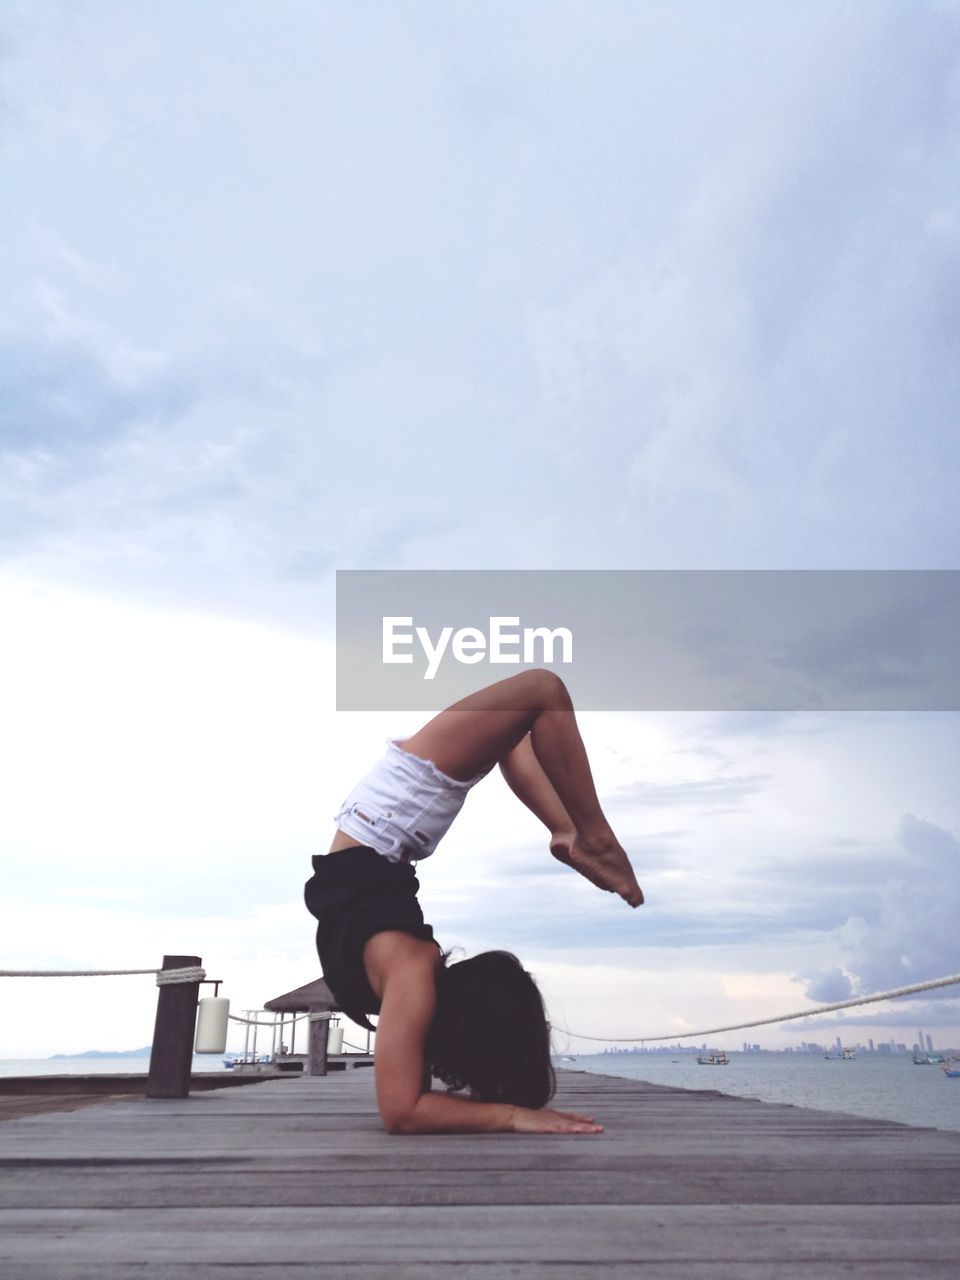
[{"x1": 0, "y1": 1071, "x2": 960, "y2": 1280}]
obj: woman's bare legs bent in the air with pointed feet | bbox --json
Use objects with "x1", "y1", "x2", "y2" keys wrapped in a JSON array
[{"x1": 399, "y1": 671, "x2": 644, "y2": 906}]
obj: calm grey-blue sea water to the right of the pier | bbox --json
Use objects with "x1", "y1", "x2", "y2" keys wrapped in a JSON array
[{"x1": 570, "y1": 1051, "x2": 960, "y2": 1130}]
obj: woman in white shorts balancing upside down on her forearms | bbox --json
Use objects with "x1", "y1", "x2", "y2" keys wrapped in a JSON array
[{"x1": 305, "y1": 671, "x2": 644, "y2": 1133}]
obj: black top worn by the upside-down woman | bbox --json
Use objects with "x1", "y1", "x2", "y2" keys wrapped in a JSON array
[{"x1": 303, "y1": 845, "x2": 439, "y2": 1030}]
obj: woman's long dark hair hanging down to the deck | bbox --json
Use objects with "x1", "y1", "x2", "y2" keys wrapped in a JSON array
[{"x1": 426, "y1": 951, "x2": 557, "y2": 1107}]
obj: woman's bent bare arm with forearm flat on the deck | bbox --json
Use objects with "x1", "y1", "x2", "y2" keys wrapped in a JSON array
[{"x1": 365, "y1": 933, "x2": 602, "y2": 1134}]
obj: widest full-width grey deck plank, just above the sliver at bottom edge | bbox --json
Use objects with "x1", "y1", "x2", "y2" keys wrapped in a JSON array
[{"x1": 0, "y1": 1204, "x2": 960, "y2": 1274}]
